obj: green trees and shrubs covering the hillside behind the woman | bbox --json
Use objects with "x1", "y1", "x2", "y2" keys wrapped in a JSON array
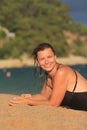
[{"x1": 0, "y1": 0, "x2": 87, "y2": 58}]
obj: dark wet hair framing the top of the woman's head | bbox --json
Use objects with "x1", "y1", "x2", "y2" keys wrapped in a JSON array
[{"x1": 32, "y1": 43, "x2": 55, "y2": 61}]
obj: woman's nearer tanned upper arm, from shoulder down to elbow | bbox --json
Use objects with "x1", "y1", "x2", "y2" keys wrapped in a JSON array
[{"x1": 50, "y1": 67, "x2": 69, "y2": 106}]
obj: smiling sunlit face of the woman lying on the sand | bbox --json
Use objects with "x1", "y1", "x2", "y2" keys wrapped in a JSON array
[{"x1": 37, "y1": 48, "x2": 56, "y2": 72}]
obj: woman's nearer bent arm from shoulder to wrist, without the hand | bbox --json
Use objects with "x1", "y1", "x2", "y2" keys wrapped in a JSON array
[{"x1": 29, "y1": 67, "x2": 68, "y2": 106}]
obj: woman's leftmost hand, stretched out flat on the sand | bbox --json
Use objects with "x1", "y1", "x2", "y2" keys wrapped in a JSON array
[{"x1": 9, "y1": 96, "x2": 29, "y2": 106}]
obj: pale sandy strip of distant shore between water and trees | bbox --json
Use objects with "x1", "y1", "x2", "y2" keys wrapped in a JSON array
[{"x1": 0, "y1": 56, "x2": 87, "y2": 69}]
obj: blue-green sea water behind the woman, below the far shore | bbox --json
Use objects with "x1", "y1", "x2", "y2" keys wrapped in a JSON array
[{"x1": 0, "y1": 64, "x2": 87, "y2": 95}]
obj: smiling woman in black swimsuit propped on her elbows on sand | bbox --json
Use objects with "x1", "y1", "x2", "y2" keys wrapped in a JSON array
[{"x1": 9, "y1": 43, "x2": 87, "y2": 111}]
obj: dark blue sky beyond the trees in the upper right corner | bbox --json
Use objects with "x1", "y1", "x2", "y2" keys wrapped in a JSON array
[{"x1": 61, "y1": 0, "x2": 87, "y2": 26}]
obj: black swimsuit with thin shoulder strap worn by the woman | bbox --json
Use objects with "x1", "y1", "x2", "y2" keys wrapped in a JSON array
[{"x1": 61, "y1": 71, "x2": 87, "y2": 111}]
